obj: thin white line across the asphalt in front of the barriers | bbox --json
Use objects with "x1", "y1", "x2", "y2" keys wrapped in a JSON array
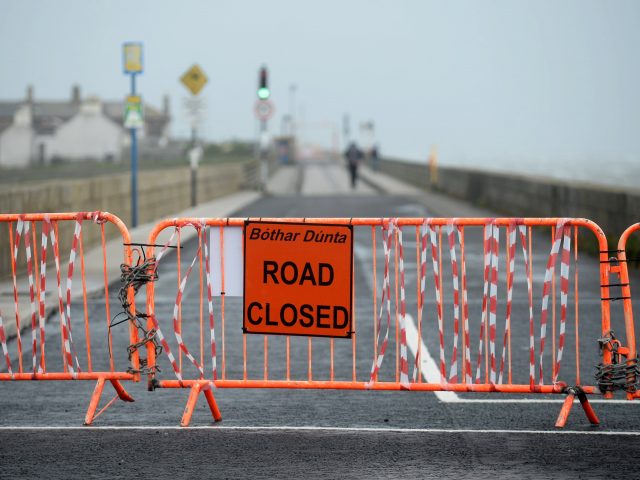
[{"x1": 0, "y1": 425, "x2": 640, "y2": 437}]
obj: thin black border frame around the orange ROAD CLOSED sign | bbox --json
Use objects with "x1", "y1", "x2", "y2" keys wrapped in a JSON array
[{"x1": 242, "y1": 219, "x2": 355, "y2": 340}]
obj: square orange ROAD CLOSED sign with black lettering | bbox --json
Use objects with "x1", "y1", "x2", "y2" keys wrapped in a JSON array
[{"x1": 243, "y1": 220, "x2": 353, "y2": 338}]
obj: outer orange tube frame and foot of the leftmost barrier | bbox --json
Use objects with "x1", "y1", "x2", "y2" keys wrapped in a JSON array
[{"x1": 0, "y1": 212, "x2": 140, "y2": 425}]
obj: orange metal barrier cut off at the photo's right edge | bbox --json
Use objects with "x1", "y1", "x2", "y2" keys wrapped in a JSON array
[{"x1": 616, "y1": 223, "x2": 640, "y2": 399}]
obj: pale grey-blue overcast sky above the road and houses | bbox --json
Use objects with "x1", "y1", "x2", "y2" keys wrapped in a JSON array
[{"x1": 0, "y1": 0, "x2": 640, "y2": 169}]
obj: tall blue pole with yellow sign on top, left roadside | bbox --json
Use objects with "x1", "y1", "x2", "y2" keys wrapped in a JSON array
[{"x1": 122, "y1": 42, "x2": 143, "y2": 227}]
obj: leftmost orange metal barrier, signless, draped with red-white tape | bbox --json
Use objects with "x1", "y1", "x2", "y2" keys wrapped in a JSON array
[{"x1": 0, "y1": 212, "x2": 140, "y2": 425}]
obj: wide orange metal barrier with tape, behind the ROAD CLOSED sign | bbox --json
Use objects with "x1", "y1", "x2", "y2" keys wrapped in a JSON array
[{"x1": 141, "y1": 218, "x2": 612, "y2": 427}]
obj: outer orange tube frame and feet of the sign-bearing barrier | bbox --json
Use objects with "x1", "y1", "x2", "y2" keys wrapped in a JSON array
[{"x1": 147, "y1": 217, "x2": 612, "y2": 427}]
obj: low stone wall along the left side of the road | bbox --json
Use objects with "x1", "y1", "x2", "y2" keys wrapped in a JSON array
[{"x1": 0, "y1": 160, "x2": 258, "y2": 276}]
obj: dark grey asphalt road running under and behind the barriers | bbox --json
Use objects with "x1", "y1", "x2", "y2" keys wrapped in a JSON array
[{"x1": 0, "y1": 159, "x2": 640, "y2": 478}]
